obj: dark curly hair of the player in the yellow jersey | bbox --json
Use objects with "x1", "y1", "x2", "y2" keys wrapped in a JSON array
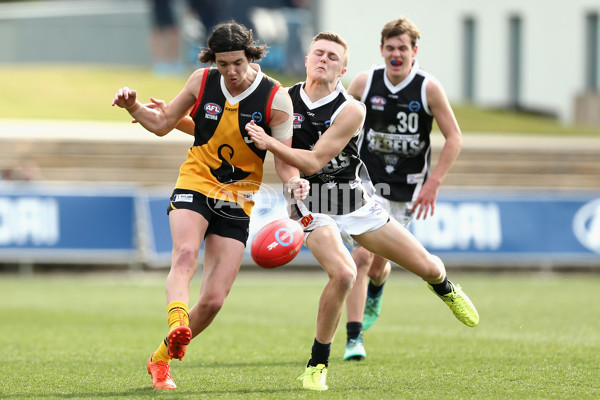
[{"x1": 198, "y1": 20, "x2": 268, "y2": 64}]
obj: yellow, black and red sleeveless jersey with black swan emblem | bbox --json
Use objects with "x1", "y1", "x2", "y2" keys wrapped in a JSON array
[{"x1": 176, "y1": 68, "x2": 281, "y2": 215}]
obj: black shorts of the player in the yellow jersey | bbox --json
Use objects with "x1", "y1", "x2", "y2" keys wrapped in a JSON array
[{"x1": 167, "y1": 189, "x2": 250, "y2": 246}]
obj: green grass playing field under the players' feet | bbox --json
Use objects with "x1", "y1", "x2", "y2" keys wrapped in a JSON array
[{"x1": 0, "y1": 269, "x2": 600, "y2": 399}]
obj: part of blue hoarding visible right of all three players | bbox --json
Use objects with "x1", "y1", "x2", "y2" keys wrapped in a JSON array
[{"x1": 410, "y1": 190, "x2": 600, "y2": 265}]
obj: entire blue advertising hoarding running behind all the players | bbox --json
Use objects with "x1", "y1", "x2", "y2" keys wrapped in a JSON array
[{"x1": 0, "y1": 183, "x2": 600, "y2": 267}]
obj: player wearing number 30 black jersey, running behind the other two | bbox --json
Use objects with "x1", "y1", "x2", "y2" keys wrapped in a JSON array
[{"x1": 344, "y1": 17, "x2": 462, "y2": 360}]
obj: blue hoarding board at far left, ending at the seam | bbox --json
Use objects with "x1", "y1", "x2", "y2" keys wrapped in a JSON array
[{"x1": 0, "y1": 183, "x2": 138, "y2": 263}]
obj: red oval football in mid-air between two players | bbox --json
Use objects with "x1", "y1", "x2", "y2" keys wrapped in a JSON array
[{"x1": 250, "y1": 218, "x2": 304, "y2": 268}]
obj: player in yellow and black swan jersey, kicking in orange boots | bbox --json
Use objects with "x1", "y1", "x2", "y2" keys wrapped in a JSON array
[{"x1": 112, "y1": 21, "x2": 308, "y2": 389}]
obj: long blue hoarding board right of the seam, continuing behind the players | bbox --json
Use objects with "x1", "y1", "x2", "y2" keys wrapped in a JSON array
[{"x1": 142, "y1": 185, "x2": 600, "y2": 267}]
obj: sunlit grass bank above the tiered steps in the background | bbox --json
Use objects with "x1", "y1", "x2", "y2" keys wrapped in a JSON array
[{"x1": 0, "y1": 64, "x2": 598, "y2": 136}]
